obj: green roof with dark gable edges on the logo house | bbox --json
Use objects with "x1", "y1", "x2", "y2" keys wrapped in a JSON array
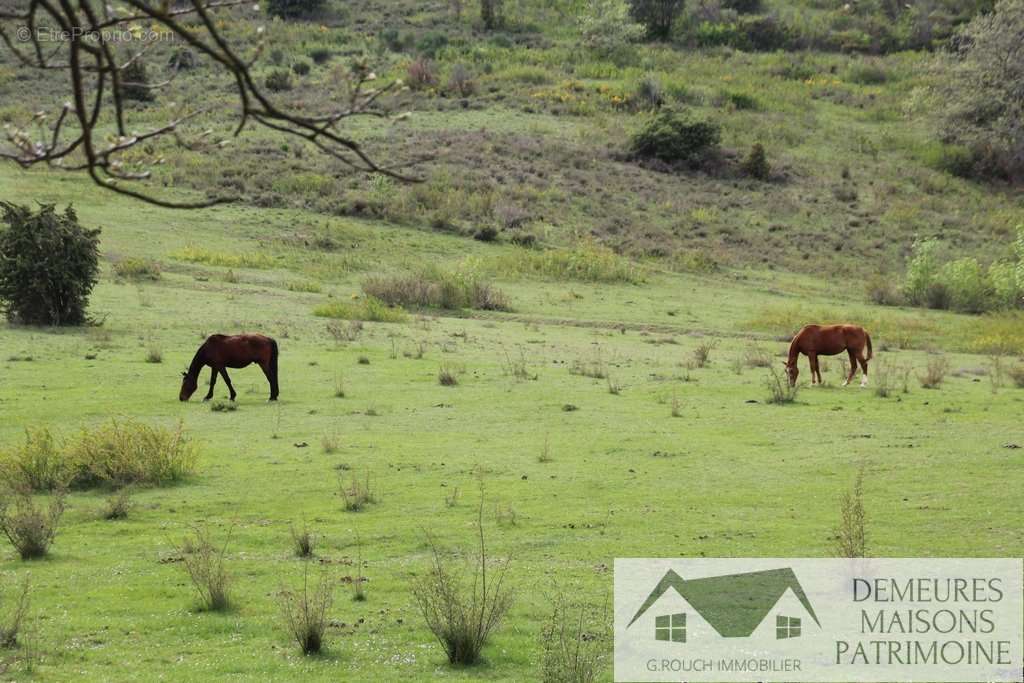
[{"x1": 627, "y1": 567, "x2": 821, "y2": 638}]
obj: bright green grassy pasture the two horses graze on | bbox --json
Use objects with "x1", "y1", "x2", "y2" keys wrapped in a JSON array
[{"x1": 0, "y1": 162, "x2": 1024, "y2": 681}]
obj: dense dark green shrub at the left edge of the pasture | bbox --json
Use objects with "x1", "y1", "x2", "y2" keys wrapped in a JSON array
[{"x1": 0, "y1": 202, "x2": 99, "y2": 325}]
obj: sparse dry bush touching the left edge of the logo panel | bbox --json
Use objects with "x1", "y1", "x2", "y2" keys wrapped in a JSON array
[{"x1": 540, "y1": 594, "x2": 610, "y2": 683}]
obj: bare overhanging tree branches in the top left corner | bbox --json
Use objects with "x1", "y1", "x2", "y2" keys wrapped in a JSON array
[{"x1": 0, "y1": 0, "x2": 415, "y2": 208}]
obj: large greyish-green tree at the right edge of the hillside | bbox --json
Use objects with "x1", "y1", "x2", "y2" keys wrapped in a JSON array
[{"x1": 938, "y1": 0, "x2": 1024, "y2": 178}]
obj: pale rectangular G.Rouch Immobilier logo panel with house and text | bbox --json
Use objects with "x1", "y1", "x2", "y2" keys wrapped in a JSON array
[{"x1": 614, "y1": 558, "x2": 1024, "y2": 682}]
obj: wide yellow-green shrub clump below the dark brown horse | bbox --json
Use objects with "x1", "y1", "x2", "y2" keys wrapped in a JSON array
[{"x1": 66, "y1": 420, "x2": 199, "y2": 487}]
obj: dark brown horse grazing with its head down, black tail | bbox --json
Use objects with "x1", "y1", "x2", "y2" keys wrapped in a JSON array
[{"x1": 178, "y1": 335, "x2": 278, "y2": 400}]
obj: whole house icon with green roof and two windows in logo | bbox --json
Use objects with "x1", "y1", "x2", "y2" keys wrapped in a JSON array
[{"x1": 627, "y1": 567, "x2": 821, "y2": 643}]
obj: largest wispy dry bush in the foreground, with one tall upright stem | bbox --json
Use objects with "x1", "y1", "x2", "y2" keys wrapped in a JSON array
[{"x1": 414, "y1": 500, "x2": 514, "y2": 665}]
